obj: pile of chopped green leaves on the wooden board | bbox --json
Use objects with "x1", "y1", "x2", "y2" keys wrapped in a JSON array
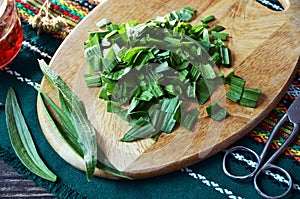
[{"x1": 84, "y1": 7, "x2": 259, "y2": 142}]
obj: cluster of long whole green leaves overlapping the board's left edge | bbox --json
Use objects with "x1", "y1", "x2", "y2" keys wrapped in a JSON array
[{"x1": 36, "y1": 60, "x2": 131, "y2": 181}]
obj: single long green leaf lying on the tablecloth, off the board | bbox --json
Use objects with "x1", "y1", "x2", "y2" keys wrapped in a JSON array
[{"x1": 5, "y1": 88, "x2": 57, "y2": 182}]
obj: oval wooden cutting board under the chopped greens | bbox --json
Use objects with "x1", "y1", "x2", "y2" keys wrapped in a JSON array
[{"x1": 37, "y1": 0, "x2": 300, "y2": 179}]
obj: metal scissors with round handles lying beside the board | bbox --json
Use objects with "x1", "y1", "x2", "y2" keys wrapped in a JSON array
[{"x1": 223, "y1": 96, "x2": 300, "y2": 199}]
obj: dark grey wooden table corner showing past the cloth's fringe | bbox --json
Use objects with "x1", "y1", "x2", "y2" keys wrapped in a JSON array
[{"x1": 0, "y1": 161, "x2": 56, "y2": 199}]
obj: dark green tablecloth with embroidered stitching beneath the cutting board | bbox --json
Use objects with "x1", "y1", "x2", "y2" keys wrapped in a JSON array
[{"x1": 0, "y1": 0, "x2": 300, "y2": 199}]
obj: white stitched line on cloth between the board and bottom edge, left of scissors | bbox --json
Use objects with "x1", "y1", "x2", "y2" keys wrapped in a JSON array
[{"x1": 181, "y1": 168, "x2": 243, "y2": 199}]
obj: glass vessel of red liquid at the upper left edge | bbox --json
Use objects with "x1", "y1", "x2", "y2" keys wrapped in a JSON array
[{"x1": 0, "y1": 0, "x2": 23, "y2": 69}]
